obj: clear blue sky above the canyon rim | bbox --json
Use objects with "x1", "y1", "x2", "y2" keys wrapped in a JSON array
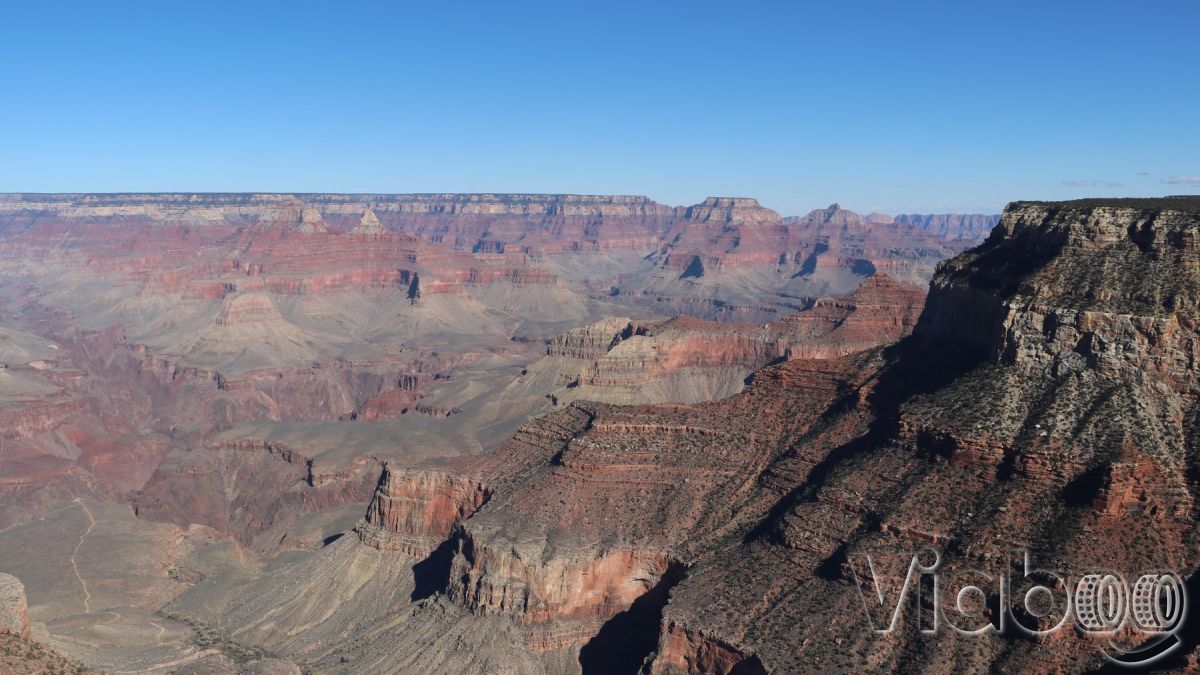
[{"x1": 0, "y1": 0, "x2": 1200, "y2": 214}]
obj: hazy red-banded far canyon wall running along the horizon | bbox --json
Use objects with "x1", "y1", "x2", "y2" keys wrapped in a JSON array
[{"x1": 0, "y1": 195, "x2": 988, "y2": 329}]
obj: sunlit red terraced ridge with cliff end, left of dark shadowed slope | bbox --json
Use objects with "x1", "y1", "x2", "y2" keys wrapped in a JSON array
[{"x1": 427, "y1": 362, "x2": 878, "y2": 650}]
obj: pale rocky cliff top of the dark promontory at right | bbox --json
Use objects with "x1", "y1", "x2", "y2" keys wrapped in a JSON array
[{"x1": 922, "y1": 199, "x2": 1200, "y2": 392}]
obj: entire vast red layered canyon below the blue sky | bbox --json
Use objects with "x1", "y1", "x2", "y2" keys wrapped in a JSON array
[{"x1": 9, "y1": 195, "x2": 1200, "y2": 673}]
